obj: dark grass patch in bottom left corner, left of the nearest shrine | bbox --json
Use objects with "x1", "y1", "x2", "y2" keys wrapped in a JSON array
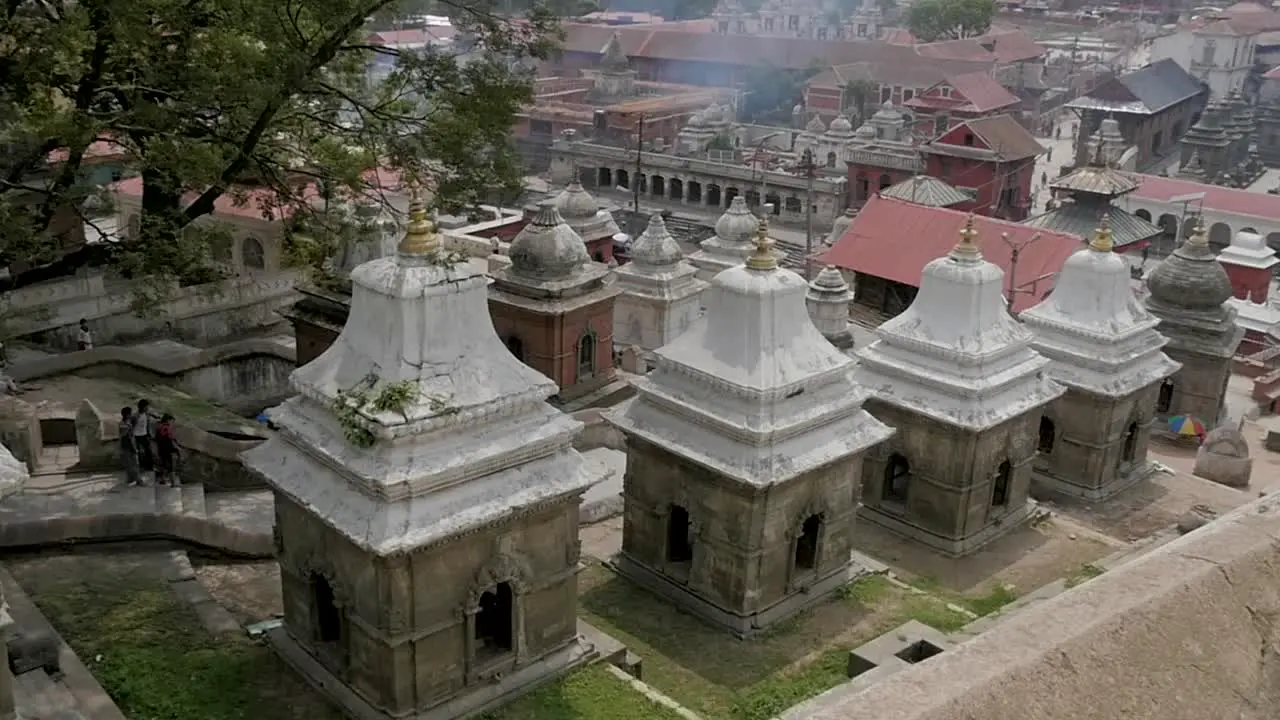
[{"x1": 21, "y1": 561, "x2": 342, "y2": 720}]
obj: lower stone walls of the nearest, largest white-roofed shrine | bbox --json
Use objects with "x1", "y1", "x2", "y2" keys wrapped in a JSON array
[{"x1": 275, "y1": 495, "x2": 580, "y2": 717}]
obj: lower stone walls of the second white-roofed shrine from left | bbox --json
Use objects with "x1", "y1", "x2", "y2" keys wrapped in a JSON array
[{"x1": 618, "y1": 437, "x2": 861, "y2": 637}]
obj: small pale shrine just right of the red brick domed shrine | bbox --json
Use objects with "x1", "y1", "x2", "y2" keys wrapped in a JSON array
[{"x1": 613, "y1": 214, "x2": 707, "y2": 351}]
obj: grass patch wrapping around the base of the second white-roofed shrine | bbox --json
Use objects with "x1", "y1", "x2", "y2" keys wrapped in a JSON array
[{"x1": 579, "y1": 562, "x2": 969, "y2": 720}]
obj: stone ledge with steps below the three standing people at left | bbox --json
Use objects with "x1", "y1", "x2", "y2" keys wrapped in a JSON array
[{"x1": 0, "y1": 474, "x2": 275, "y2": 557}]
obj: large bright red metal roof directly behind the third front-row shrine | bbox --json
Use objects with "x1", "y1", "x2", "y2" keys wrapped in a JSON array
[{"x1": 818, "y1": 195, "x2": 1084, "y2": 313}]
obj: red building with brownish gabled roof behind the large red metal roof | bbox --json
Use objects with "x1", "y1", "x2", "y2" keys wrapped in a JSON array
[{"x1": 920, "y1": 115, "x2": 1044, "y2": 220}]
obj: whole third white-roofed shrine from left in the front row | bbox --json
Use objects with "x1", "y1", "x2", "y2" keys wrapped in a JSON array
[{"x1": 855, "y1": 215, "x2": 1065, "y2": 556}]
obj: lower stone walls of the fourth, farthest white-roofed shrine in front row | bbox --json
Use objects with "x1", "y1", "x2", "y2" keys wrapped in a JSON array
[{"x1": 1032, "y1": 383, "x2": 1161, "y2": 500}]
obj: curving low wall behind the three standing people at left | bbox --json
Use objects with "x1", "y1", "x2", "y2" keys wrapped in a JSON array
[{"x1": 10, "y1": 340, "x2": 296, "y2": 414}]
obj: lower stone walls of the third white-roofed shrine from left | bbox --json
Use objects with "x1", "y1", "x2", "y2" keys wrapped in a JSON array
[{"x1": 859, "y1": 400, "x2": 1041, "y2": 556}]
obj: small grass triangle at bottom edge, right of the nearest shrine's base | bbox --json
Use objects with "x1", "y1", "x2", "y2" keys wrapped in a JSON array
[{"x1": 481, "y1": 665, "x2": 680, "y2": 720}]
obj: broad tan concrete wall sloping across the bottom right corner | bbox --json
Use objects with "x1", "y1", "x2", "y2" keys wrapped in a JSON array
[{"x1": 783, "y1": 495, "x2": 1280, "y2": 720}]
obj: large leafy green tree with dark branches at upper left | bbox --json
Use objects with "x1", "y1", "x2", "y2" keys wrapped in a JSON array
[{"x1": 0, "y1": 0, "x2": 554, "y2": 299}]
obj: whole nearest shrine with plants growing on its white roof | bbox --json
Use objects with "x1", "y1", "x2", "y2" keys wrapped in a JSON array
[{"x1": 242, "y1": 204, "x2": 600, "y2": 720}]
